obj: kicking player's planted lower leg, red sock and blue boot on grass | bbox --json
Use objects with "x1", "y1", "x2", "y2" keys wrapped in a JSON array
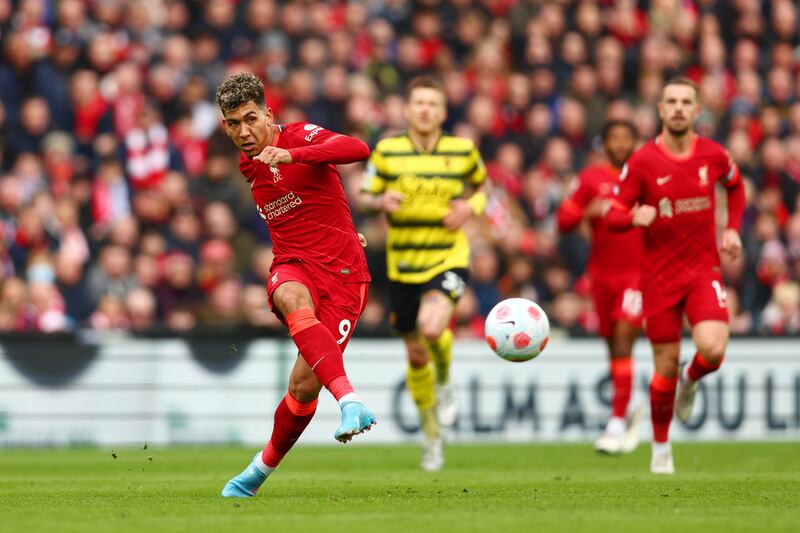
[{"x1": 222, "y1": 388, "x2": 318, "y2": 498}]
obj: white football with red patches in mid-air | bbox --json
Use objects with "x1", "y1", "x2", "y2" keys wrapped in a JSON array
[{"x1": 484, "y1": 298, "x2": 550, "y2": 363}]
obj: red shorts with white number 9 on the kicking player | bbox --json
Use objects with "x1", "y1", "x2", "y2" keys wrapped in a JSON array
[{"x1": 267, "y1": 261, "x2": 369, "y2": 351}]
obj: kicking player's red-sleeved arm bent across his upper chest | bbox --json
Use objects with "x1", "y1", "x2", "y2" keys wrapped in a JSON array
[{"x1": 254, "y1": 124, "x2": 369, "y2": 166}]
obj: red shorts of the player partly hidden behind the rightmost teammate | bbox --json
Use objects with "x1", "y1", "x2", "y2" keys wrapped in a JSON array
[{"x1": 592, "y1": 275, "x2": 642, "y2": 339}]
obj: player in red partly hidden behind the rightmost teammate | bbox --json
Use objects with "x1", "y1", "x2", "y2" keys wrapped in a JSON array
[{"x1": 557, "y1": 121, "x2": 642, "y2": 454}]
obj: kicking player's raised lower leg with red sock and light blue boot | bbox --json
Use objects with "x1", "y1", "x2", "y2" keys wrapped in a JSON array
[{"x1": 286, "y1": 308, "x2": 375, "y2": 442}]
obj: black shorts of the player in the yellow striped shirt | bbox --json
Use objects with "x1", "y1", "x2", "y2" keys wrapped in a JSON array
[{"x1": 389, "y1": 268, "x2": 469, "y2": 335}]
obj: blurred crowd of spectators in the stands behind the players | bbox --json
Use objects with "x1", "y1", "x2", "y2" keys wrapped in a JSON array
[{"x1": 0, "y1": 0, "x2": 800, "y2": 336}]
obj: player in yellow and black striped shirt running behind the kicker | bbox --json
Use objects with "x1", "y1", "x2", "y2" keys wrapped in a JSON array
[{"x1": 359, "y1": 77, "x2": 486, "y2": 471}]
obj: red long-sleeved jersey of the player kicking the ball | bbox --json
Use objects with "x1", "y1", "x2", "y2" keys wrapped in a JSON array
[{"x1": 239, "y1": 122, "x2": 370, "y2": 282}]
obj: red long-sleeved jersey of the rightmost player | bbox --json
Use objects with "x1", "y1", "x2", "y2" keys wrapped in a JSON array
[{"x1": 607, "y1": 135, "x2": 744, "y2": 292}]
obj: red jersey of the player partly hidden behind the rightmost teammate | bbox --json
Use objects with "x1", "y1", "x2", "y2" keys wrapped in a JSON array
[{"x1": 558, "y1": 165, "x2": 642, "y2": 278}]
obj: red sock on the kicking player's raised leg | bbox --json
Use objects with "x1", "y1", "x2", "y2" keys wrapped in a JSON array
[{"x1": 286, "y1": 309, "x2": 353, "y2": 402}]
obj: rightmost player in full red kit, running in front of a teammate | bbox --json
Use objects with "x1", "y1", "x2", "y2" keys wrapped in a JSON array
[{"x1": 606, "y1": 78, "x2": 745, "y2": 474}]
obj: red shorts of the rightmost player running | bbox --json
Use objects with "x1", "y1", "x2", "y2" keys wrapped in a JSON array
[{"x1": 644, "y1": 273, "x2": 728, "y2": 344}]
